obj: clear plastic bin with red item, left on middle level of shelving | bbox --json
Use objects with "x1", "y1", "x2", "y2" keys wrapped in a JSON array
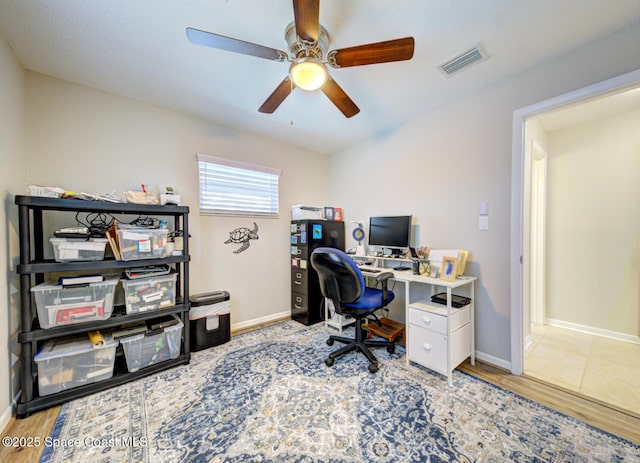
[{"x1": 31, "y1": 277, "x2": 118, "y2": 329}]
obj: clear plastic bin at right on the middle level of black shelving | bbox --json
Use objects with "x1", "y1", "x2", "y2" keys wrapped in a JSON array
[{"x1": 122, "y1": 273, "x2": 177, "y2": 315}]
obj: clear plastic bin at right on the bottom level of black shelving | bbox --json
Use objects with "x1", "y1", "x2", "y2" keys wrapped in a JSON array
[{"x1": 120, "y1": 315, "x2": 184, "y2": 372}]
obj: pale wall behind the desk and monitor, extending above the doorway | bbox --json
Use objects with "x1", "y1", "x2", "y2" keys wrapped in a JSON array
[{"x1": 329, "y1": 25, "x2": 640, "y2": 368}]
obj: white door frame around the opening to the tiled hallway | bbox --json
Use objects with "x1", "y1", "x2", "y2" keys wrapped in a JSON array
[{"x1": 510, "y1": 70, "x2": 640, "y2": 375}]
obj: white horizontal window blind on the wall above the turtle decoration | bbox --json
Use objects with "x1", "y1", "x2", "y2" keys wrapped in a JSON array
[{"x1": 197, "y1": 154, "x2": 280, "y2": 217}]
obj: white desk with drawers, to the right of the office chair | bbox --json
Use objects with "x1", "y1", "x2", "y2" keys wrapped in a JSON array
[{"x1": 360, "y1": 266, "x2": 477, "y2": 385}]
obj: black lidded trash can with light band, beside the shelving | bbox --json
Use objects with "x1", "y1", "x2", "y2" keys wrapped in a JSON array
[{"x1": 189, "y1": 291, "x2": 231, "y2": 352}]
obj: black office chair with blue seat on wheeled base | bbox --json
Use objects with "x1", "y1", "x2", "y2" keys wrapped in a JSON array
[{"x1": 311, "y1": 248, "x2": 396, "y2": 373}]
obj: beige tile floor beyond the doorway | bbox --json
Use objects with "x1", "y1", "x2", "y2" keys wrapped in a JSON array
[{"x1": 524, "y1": 325, "x2": 640, "y2": 415}]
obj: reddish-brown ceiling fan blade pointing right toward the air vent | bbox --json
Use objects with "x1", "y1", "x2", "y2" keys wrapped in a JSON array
[{"x1": 327, "y1": 37, "x2": 415, "y2": 68}]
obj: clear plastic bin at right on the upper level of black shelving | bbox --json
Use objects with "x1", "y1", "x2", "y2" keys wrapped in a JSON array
[{"x1": 117, "y1": 225, "x2": 169, "y2": 260}]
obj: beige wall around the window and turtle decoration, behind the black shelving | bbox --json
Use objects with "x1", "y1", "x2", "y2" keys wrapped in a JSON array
[{"x1": 27, "y1": 72, "x2": 327, "y2": 325}]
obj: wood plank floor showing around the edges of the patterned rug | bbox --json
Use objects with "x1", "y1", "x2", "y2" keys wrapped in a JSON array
[{"x1": 0, "y1": 326, "x2": 640, "y2": 463}]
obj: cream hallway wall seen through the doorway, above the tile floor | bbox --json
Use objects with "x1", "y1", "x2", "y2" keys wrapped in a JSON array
[{"x1": 546, "y1": 110, "x2": 640, "y2": 336}]
